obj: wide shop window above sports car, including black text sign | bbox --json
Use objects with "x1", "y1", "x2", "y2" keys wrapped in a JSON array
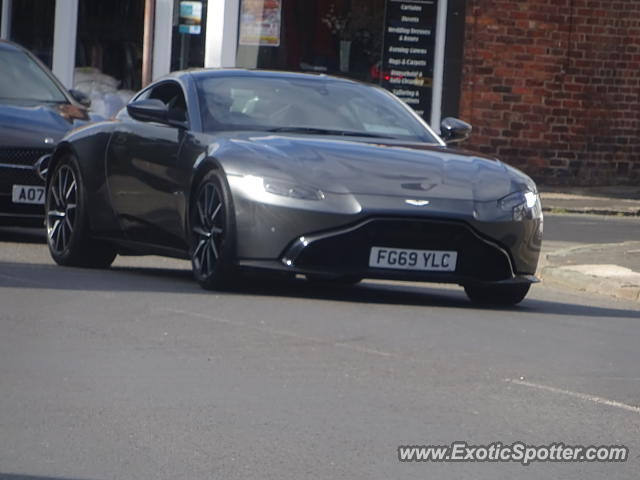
[{"x1": 237, "y1": 0, "x2": 441, "y2": 119}]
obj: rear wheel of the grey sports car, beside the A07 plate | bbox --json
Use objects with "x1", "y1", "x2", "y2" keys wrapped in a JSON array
[{"x1": 45, "y1": 156, "x2": 117, "y2": 268}]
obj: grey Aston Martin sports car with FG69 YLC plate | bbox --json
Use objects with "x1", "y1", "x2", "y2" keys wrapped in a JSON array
[{"x1": 46, "y1": 70, "x2": 543, "y2": 304}]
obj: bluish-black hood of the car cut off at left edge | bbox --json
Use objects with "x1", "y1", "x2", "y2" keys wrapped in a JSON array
[{"x1": 0, "y1": 104, "x2": 88, "y2": 148}]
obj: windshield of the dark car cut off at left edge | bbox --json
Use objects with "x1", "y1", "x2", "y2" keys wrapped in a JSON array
[{"x1": 0, "y1": 48, "x2": 67, "y2": 103}]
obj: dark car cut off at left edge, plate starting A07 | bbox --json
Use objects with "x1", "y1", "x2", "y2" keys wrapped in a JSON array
[{"x1": 0, "y1": 41, "x2": 89, "y2": 226}]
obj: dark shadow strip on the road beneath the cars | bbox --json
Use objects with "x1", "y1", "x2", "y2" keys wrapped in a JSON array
[{"x1": 0, "y1": 262, "x2": 640, "y2": 319}]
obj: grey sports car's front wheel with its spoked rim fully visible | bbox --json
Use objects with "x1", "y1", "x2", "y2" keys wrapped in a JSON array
[{"x1": 189, "y1": 171, "x2": 236, "y2": 290}]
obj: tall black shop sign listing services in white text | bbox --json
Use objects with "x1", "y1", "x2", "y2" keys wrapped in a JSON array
[{"x1": 380, "y1": 0, "x2": 438, "y2": 119}]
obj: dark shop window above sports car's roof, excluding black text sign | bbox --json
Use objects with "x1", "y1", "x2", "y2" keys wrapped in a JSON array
[{"x1": 237, "y1": 0, "x2": 385, "y2": 83}]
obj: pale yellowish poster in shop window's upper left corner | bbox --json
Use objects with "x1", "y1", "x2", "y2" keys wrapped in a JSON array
[{"x1": 239, "y1": 0, "x2": 282, "y2": 47}]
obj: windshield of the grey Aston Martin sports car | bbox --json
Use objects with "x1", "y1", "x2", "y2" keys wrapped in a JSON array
[{"x1": 196, "y1": 75, "x2": 437, "y2": 143}]
